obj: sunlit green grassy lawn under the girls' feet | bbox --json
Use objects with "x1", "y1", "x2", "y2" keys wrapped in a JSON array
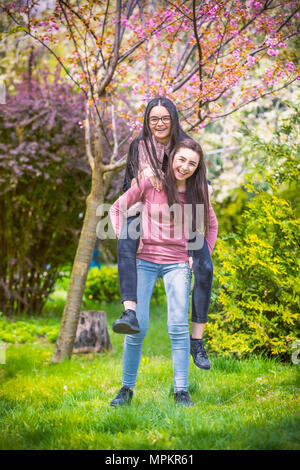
[{"x1": 0, "y1": 295, "x2": 300, "y2": 450}]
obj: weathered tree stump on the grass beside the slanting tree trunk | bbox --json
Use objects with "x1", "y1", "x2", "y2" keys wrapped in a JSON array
[{"x1": 73, "y1": 310, "x2": 112, "y2": 353}]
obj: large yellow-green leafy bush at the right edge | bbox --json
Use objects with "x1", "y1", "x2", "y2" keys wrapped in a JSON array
[{"x1": 206, "y1": 106, "x2": 300, "y2": 359}]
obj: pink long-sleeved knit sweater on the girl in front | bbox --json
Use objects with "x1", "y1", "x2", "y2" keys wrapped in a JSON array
[{"x1": 109, "y1": 178, "x2": 218, "y2": 264}]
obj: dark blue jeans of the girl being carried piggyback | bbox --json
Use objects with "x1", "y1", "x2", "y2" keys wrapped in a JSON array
[{"x1": 118, "y1": 216, "x2": 213, "y2": 323}]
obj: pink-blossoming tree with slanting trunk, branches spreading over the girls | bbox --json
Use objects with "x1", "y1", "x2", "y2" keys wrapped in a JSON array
[{"x1": 0, "y1": 0, "x2": 300, "y2": 362}]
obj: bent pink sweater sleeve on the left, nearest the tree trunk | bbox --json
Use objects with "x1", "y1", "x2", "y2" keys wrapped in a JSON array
[{"x1": 109, "y1": 178, "x2": 145, "y2": 238}]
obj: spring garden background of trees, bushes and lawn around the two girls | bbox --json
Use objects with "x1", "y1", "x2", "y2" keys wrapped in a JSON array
[{"x1": 0, "y1": 0, "x2": 300, "y2": 450}]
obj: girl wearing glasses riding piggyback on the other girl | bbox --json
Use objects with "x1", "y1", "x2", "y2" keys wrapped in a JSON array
[{"x1": 113, "y1": 98, "x2": 216, "y2": 369}]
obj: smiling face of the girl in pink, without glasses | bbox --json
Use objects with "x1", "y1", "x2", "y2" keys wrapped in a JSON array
[{"x1": 173, "y1": 148, "x2": 200, "y2": 190}]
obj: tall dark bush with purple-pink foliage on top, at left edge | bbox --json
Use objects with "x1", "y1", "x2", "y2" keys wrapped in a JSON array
[{"x1": 0, "y1": 69, "x2": 91, "y2": 316}]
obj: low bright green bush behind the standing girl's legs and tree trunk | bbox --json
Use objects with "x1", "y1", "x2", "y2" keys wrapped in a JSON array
[{"x1": 84, "y1": 266, "x2": 166, "y2": 303}]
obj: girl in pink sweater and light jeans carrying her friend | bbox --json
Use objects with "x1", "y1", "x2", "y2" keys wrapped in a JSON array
[{"x1": 110, "y1": 139, "x2": 218, "y2": 406}]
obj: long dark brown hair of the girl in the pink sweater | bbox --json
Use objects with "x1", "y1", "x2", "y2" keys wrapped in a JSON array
[{"x1": 164, "y1": 138, "x2": 209, "y2": 233}]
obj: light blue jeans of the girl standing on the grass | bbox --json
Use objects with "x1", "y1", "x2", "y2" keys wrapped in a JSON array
[{"x1": 122, "y1": 259, "x2": 191, "y2": 392}]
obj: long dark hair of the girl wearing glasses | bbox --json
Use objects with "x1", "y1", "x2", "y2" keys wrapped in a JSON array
[{"x1": 126, "y1": 96, "x2": 188, "y2": 181}]
